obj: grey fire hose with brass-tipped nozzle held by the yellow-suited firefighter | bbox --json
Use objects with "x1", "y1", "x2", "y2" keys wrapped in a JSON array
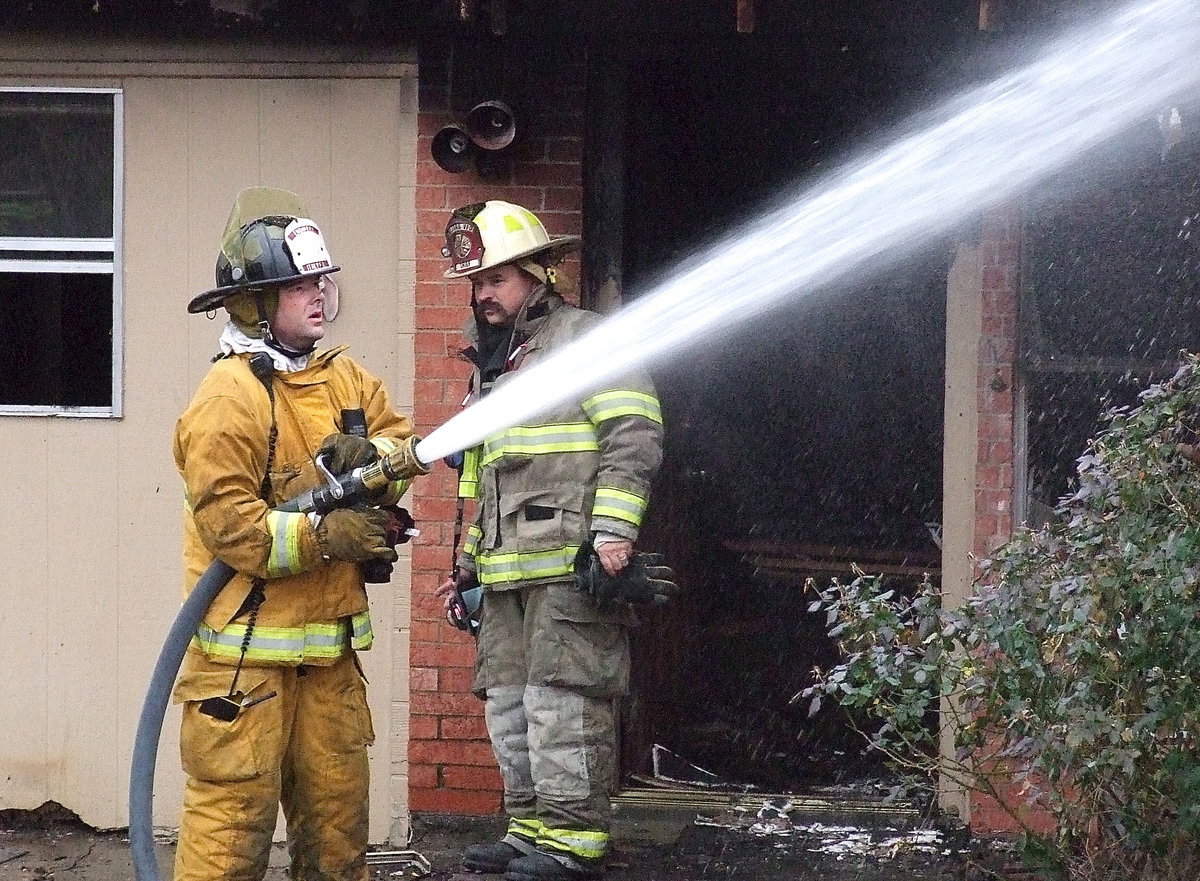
[{"x1": 130, "y1": 436, "x2": 430, "y2": 881}]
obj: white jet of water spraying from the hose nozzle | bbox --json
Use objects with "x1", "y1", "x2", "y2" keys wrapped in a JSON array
[{"x1": 416, "y1": 0, "x2": 1200, "y2": 470}]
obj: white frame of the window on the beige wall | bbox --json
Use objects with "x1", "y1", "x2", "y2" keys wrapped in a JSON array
[{"x1": 0, "y1": 85, "x2": 125, "y2": 419}]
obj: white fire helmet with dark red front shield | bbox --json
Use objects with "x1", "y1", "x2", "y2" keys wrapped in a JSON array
[{"x1": 442, "y1": 199, "x2": 580, "y2": 278}]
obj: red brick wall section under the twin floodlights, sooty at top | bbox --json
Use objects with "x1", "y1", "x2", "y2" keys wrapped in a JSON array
[{"x1": 408, "y1": 39, "x2": 583, "y2": 814}]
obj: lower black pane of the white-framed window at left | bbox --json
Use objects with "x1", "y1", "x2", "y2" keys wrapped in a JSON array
[{"x1": 0, "y1": 272, "x2": 113, "y2": 407}]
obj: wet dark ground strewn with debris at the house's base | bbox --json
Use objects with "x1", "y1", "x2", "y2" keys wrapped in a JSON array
[{"x1": 0, "y1": 804, "x2": 1016, "y2": 881}]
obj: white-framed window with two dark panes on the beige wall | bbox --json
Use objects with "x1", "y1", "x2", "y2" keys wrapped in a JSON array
[{"x1": 0, "y1": 89, "x2": 121, "y2": 416}]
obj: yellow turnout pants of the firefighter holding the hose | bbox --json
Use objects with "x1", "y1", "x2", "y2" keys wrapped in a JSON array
[{"x1": 174, "y1": 649, "x2": 374, "y2": 881}]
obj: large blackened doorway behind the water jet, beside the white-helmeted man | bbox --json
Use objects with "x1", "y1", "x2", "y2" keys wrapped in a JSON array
[{"x1": 609, "y1": 4, "x2": 977, "y2": 792}]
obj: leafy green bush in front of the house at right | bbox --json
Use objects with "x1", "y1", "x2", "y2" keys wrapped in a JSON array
[{"x1": 804, "y1": 356, "x2": 1200, "y2": 881}]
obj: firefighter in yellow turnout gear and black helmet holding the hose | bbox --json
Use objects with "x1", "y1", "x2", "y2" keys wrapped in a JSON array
[{"x1": 174, "y1": 188, "x2": 414, "y2": 881}]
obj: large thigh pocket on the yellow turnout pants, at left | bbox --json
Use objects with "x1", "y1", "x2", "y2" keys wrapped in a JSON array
[{"x1": 173, "y1": 669, "x2": 283, "y2": 783}]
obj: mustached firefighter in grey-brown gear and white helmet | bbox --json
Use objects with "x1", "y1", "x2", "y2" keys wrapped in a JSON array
[{"x1": 439, "y1": 200, "x2": 662, "y2": 881}]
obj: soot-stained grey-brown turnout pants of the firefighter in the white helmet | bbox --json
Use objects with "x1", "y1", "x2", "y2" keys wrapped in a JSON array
[{"x1": 474, "y1": 583, "x2": 630, "y2": 859}]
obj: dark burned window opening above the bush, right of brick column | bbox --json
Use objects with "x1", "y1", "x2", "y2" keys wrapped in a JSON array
[{"x1": 1015, "y1": 100, "x2": 1200, "y2": 526}]
